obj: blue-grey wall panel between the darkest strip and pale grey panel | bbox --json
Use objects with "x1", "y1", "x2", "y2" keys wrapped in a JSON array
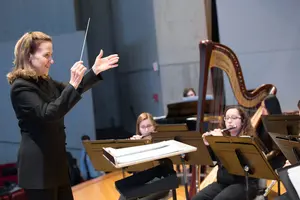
[{"x1": 113, "y1": 0, "x2": 162, "y2": 133}]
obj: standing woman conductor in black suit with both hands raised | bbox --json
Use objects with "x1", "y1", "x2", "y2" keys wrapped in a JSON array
[{"x1": 7, "y1": 32, "x2": 119, "y2": 200}]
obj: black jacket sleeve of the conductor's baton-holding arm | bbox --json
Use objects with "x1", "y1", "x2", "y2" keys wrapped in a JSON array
[{"x1": 11, "y1": 80, "x2": 81, "y2": 121}]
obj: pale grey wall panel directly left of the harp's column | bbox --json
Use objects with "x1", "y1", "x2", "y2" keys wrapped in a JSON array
[{"x1": 154, "y1": 0, "x2": 207, "y2": 113}]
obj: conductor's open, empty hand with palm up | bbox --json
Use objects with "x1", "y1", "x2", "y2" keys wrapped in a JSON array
[{"x1": 92, "y1": 49, "x2": 119, "y2": 75}]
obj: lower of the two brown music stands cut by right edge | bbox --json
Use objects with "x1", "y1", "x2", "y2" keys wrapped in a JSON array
[{"x1": 269, "y1": 132, "x2": 300, "y2": 164}]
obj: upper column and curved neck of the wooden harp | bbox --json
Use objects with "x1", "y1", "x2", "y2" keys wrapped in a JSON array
[{"x1": 196, "y1": 40, "x2": 276, "y2": 132}]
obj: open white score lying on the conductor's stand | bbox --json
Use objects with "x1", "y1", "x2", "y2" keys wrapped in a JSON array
[{"x1": 103, "y1": 140, "x2": 197, "y2": 168}]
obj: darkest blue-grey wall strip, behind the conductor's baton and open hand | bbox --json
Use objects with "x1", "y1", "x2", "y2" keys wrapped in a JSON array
[{"x1": 75, "y1": 0, "x2": 122, "y2": 129}]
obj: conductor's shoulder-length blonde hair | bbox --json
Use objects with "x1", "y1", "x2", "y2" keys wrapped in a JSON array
[{"x1": 6, "y1": 31, "x2": 52, "y2": 84}]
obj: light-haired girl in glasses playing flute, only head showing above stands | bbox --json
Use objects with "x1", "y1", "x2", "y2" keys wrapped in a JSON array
[{"x1": 130, "y1": 112, "x2": 156, "y2": 140}]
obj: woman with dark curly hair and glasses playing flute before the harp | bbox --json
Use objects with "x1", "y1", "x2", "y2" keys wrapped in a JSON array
[{"x1": 192, "y1": 106, "x2": 258, "y2": 200}]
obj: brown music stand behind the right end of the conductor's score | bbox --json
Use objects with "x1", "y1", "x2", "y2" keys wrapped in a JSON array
[{"x1": 152, "y1": 131, "x2": 213, "y2": 200}]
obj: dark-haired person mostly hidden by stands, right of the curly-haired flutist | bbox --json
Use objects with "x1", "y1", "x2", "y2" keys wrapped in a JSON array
[{"x1": 257, "y1": 95, "x2": 286, "y2": 169}]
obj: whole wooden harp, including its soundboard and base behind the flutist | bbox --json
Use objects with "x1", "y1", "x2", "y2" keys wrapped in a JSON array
[{"x1": 190, "y1": 40, "x2": 277, "y2": 196}]
